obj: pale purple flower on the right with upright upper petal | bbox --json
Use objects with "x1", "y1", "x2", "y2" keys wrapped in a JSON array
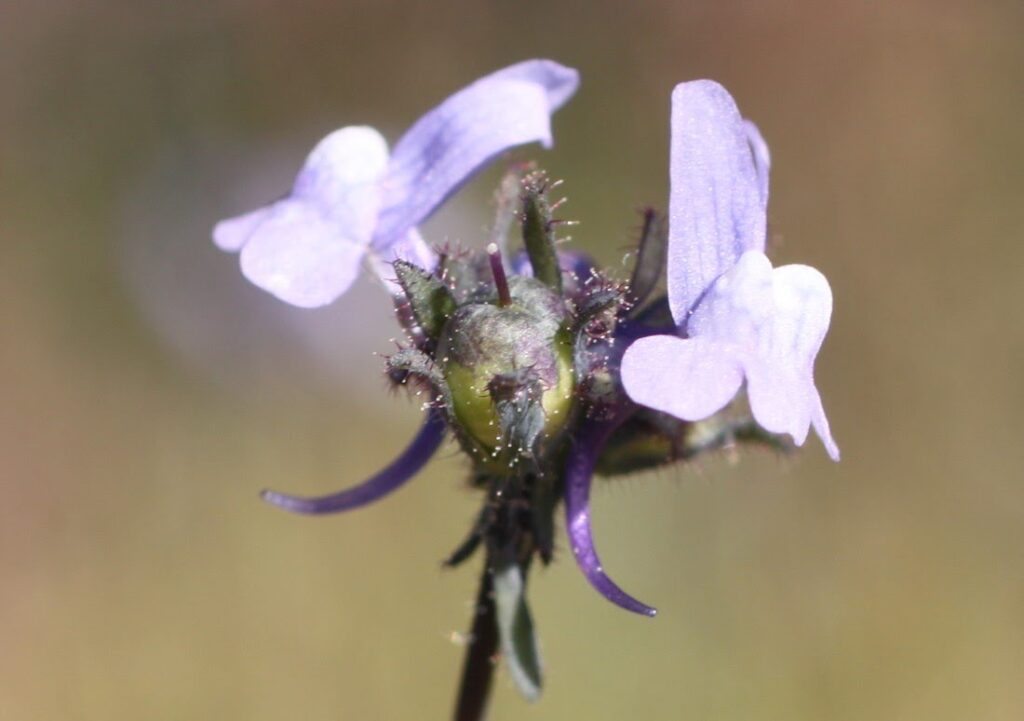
[{"x1": 622, "y1": 80, "x2": 839, "y2": 461}]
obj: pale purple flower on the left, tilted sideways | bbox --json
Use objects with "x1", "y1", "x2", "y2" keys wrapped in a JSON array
[{"x1": 213, "y1": 60, "x2": 579, "y2": 307}]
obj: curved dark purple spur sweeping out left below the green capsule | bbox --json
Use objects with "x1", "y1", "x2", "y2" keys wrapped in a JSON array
[{"x1": 260, "y1": 409, "x2": 445, "y2": 515}]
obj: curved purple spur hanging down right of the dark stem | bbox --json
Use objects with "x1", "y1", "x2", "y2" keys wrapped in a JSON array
[{"x1": 565, "y1": 414, "x2": 657, "y2": 617}]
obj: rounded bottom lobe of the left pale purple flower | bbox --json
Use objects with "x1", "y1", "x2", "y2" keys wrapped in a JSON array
[{"x1": 241, "y1": 200, "x2": 366, "y2": 308}]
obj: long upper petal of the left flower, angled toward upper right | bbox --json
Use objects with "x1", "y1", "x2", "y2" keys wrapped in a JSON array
[{"x1": 375, "y1": 60, "x2": 579, "y2": 248}]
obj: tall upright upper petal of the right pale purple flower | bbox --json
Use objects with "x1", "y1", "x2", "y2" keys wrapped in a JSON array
[{"x1": 668, "y1": 80, "x2": 766, "y2": 328}]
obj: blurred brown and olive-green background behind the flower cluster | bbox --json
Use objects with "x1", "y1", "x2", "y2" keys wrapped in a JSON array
[{"x1": 0, "y1": 0, "x2": 1024, "y2": 721}]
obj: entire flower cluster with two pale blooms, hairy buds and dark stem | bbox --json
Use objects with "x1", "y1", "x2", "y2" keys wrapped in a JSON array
[{"x1": 214, "y1": 60, "x2": 839, "y2": 718}]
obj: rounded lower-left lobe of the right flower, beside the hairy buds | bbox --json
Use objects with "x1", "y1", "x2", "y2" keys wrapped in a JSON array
[{"x1": 622, "y1": 336, "x2": 743, "y2": 421}]
